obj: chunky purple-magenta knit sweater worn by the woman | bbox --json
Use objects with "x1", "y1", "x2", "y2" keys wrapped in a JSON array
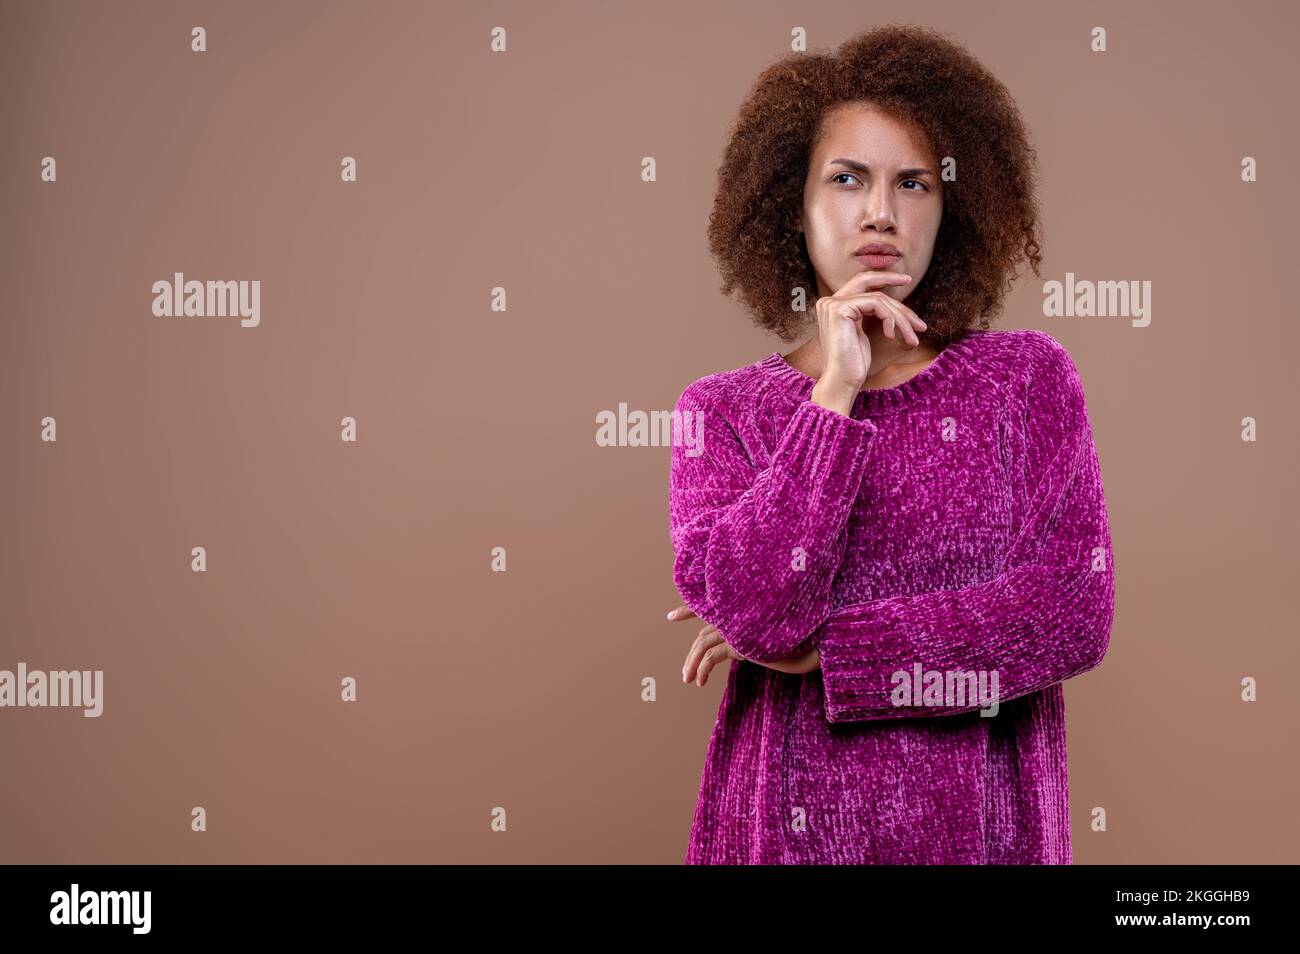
[{"x1": 670, "y1": 330, "x2": 1114, "y2": 864}]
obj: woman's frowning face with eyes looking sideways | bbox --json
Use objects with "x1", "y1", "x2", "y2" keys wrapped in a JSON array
[{"x1": 798, "y1": 103, "x2": 944, "y2": 302}]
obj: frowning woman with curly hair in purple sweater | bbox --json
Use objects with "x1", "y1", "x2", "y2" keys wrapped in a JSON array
[{"x1": 670, "y1": 26, "x2": 1114, "y2": 864}]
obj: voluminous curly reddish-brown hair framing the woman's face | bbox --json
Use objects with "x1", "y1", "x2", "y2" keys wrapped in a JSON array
[{"x1": 709, "y1": 25, "x2": 1041, "y2": 348}]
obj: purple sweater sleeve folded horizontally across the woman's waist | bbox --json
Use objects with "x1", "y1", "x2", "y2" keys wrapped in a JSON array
[{"x1": 815, "y1": 333, "x2": 1114, "y2": 723}]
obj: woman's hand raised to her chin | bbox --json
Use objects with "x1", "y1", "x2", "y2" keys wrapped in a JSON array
[{"x1": 816, "y1": 270, "x2": 926, "y2": 396}]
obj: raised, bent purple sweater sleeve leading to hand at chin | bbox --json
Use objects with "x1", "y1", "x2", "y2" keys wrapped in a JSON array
[{"x1": 670, "y1": 377, "x2": 876, "y2": 663}]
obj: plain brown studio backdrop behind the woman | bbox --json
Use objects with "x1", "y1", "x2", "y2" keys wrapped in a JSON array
[{"x1": 0, "y1": 1, "x2": 1300, "y2": 864}]
